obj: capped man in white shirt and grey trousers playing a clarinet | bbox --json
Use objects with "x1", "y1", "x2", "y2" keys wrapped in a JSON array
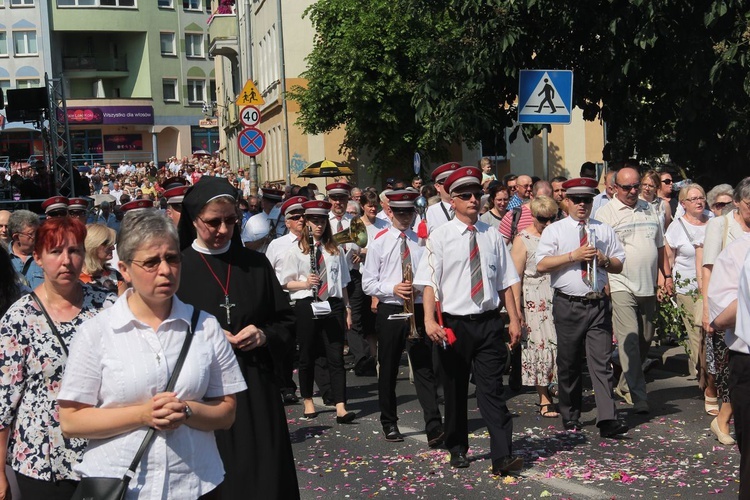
[{"x1": 536, "y1": 177, "x2": 628, "y2": 438}]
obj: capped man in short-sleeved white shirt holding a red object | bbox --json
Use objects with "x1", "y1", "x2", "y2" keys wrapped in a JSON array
[{"x1": 414, "y1": 167, "x2": 523, "y2": 475}]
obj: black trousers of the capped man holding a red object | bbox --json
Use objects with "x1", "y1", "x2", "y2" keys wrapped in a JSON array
[{"x1": 438, "y1": 313, "x2": 513, "y2": 461}]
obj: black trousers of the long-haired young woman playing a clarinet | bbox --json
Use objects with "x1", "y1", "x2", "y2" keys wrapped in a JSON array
[{"x1": 294, "y1": 298, "x2": 346, "y2": 403}]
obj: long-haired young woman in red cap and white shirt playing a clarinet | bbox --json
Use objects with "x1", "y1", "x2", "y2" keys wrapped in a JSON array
[{"x1": 281, "y1": 200, "x2": 356, "y2": 424}]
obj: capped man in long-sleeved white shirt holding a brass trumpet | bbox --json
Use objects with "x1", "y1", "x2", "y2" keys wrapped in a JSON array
[{"x1": 362, "y1": 190, "x2": 445, "y2": 448}]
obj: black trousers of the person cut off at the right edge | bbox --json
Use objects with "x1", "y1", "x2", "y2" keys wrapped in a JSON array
[{"x1": 729, "y1": 351, "x2": 750, "y2": 500}]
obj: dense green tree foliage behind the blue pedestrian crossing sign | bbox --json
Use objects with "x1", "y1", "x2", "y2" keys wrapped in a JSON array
[{"x1": 291, "y1": 0, "x2": 750, "y2": 181}]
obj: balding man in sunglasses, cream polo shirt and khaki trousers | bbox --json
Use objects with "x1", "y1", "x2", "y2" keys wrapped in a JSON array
[{"x1": 597, "y1": 167, "x2": 672, "y2": 414}]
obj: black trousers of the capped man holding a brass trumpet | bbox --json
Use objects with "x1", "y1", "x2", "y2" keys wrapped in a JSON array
[{"x1": 375, "y1": 302, "x2": 443, "y2": 432}]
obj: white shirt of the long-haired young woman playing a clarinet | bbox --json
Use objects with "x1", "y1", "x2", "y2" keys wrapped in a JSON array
[{"x1": 279, "y1": 245, "x2": 351, "y2": 300}]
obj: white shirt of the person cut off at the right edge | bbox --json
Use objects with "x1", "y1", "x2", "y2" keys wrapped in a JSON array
[{"x1": 708, "y1": 234, "x2": 750, "y2": 354}]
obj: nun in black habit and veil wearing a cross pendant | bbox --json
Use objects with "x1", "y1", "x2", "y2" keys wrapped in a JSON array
[{"x1": 177, "y1": 176, "x2": 299, "y2": 500}]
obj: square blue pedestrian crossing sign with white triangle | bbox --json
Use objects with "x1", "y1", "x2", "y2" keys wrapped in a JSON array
[{"x1": 518, "y1": 69, "x2": 573, "y2": 124}]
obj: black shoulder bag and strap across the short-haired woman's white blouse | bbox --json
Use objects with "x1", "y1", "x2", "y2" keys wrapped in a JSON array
[{"x1": 71, "y1": 308, "x2": 200, "y2": 500}]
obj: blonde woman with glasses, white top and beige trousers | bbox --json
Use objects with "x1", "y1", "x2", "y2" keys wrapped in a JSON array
[{"x1": 664, "y1": 184, "x2": 708, "y2": 392}]
